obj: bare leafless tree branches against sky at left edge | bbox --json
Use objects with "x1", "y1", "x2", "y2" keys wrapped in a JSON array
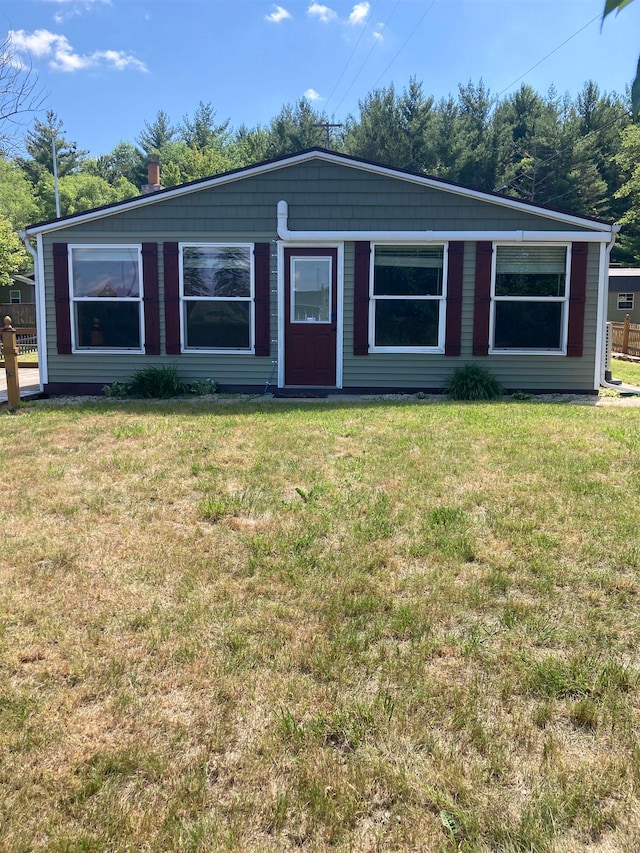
[{"x1": 0, "y1": 34, "x2": 43, "y2": 154}]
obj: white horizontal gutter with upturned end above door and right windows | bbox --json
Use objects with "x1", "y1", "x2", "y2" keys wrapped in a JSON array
[{"x1": 278, "y1": 201, "x2": 612, "y2": 243}]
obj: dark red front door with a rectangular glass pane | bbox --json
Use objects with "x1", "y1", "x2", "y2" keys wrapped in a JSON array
[{"x1": 284, "y1": 249, "x2": 338, "y2": 387}]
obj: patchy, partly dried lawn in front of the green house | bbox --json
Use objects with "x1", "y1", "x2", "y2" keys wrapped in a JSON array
[{"x1": 0, "y1": 400, "x2": 640, "y2": 853}]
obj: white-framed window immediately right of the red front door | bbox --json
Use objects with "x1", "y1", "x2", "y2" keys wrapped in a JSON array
[{"x1": 370, "y1": 245, "x2": 446, "y2": 352}]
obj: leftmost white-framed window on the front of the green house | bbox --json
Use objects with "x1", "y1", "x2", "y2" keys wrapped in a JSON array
[{"x1": 69, "y1": 245, "x2": 143, "y2": 352}]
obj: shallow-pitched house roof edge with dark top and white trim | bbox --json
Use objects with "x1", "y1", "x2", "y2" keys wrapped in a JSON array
[{"x1": 25, "y1": 148, "x2": 617, "y2": 235}]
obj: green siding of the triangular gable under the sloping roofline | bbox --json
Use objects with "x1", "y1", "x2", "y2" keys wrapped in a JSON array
[{"x1": 45, "y1": 162, "x2": 596, "y2": 240}]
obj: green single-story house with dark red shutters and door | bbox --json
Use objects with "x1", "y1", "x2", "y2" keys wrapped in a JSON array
[{"x1": 24, "y1": 149, "x2": 617, "y2": 394}]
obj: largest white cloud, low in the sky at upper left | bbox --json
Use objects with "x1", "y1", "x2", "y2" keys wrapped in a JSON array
[{"x1": 9, "y1": 30, "x2": 148, "y2": 73}]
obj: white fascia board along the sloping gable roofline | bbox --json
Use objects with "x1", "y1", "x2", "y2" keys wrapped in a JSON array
[{"x1": 26, "y1": 151, "x2": 619, "y2": 235}]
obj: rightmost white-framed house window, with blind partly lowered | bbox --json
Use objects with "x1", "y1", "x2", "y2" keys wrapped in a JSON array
[{"x1": 491, "y1": 245, "x2": 569, "y2": 353}]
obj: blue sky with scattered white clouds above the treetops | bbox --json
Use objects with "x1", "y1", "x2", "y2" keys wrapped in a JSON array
[{"x1": 5, "y1": 0, "x2": 640, "y2": 155}]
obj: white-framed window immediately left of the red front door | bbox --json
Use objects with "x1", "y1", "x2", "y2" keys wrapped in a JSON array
[{"x1": 180, "y1": 243, "x2": 254, "y2": 352}]
